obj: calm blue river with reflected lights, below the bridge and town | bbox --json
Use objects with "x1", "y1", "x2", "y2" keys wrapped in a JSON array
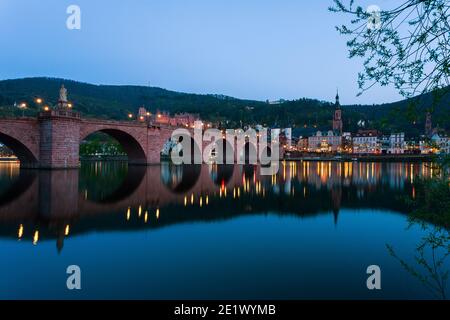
[{"x1": 0, "y1": 162, "x2": 450, "y2": 299}]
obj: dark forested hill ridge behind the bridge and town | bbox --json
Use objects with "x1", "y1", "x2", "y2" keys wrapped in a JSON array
[{"x1": 0, "y1": 78, "x2": 450, "y2": 135}]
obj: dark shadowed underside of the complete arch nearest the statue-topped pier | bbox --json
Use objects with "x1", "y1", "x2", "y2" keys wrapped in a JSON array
[{"x1": 80, "y1": 127, "x2": 147, "y2": 164}]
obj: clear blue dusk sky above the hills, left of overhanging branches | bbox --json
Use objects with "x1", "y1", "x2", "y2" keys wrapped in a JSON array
[{"x1": 0, "y1": 0, "x2": 401, "y2": 104}]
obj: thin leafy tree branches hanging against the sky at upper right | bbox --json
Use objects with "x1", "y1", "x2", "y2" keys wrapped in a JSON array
[{"x1": 329, "y1": 0, "x2": 450, "y2": 100}]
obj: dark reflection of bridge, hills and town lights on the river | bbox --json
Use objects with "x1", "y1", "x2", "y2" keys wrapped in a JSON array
[{"x1": 0, "y1": 162, "x2": 433, "y2": 249}]
